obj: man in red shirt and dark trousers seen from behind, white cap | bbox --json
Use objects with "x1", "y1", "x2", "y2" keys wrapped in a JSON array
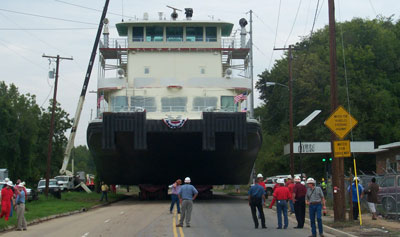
[{"x1": 273, "y1": 179, "x2": 292, "y2": 229}]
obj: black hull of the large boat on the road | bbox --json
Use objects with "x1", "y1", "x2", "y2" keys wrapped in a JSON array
[{"x1": 87, "y1": 112, "x2": 262, "y2": 185}]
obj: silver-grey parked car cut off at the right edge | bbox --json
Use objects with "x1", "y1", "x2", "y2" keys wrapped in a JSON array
[{"x1": 378, "y1": 174, "x2": 400, "y2": 212}]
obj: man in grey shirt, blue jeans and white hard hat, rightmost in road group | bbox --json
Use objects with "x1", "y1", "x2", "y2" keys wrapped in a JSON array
[{"x1": 306, "y1": 178, "x2": 326, "y2": 237}]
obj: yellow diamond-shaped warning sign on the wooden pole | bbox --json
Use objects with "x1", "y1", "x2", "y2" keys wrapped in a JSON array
[{"x1": 325, "y1": 106, "x2": 358, "y2": 139}]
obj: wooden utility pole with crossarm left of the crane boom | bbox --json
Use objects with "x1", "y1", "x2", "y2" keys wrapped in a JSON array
[{"x1": 42, "y1": 54, "x2": 73, "y2": 197}]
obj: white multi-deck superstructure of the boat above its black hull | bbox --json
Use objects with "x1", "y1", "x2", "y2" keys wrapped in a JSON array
[{"x1": 98, "y1": 10, "x2": 251, "y2": 119}]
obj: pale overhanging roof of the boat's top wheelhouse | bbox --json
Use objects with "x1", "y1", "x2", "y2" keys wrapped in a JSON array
[{"x1": 116, "y1": 20, "x2": 233, "y2": 37}]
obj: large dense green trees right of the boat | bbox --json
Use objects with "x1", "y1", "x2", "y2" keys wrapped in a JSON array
[{"x1": 256, "y1": 18, "x2": 400, "y2": 177}]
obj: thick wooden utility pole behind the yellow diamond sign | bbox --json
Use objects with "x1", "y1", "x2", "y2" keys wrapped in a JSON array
[{"x1": 328, "y1": 0, "x2": 346, "y2": 221}]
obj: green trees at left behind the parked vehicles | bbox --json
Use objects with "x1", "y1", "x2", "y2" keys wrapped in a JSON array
[{"x1": 0, "y1": 82, "x2": 72, "y2": 185}]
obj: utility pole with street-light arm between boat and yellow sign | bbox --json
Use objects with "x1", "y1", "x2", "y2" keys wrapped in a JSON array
[{"x1": 274, "y1": 45, "x2": 294, "y2": 179}]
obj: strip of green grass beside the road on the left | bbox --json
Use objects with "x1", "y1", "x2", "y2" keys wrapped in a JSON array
[{"x1": 0, "y1": 192, "x2": 123, "y2": 230}]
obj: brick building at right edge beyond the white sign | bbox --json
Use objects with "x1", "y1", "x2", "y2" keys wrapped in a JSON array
[{"x1": 374, "y1": 142, "x2": 400, "y2": 174}]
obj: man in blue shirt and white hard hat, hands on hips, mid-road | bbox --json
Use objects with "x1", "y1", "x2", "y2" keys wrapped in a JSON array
[{"x1": 176, "y1": 177, "x2": 199, "y2": 227}]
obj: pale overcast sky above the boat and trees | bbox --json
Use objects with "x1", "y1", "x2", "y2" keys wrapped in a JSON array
[{"x1": 0, "y1": 0, "x2": 400, "y2": 146}]
